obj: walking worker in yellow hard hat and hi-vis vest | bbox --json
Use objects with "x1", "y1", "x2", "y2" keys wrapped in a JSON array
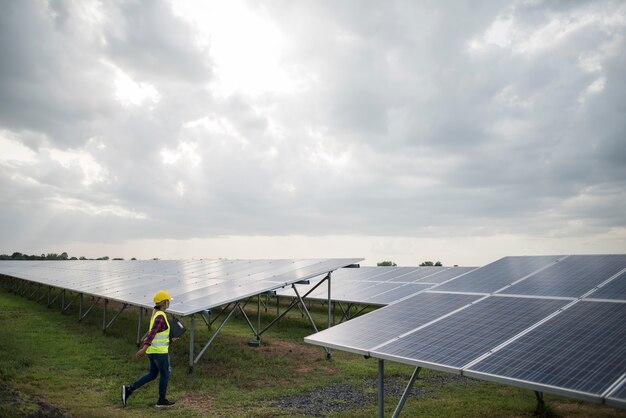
[{"x1": 122, "y1": 290, "x2": 176, "y2": 408}]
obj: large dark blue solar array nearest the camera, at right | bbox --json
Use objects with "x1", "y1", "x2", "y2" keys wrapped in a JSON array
[{"x1": 305, "y1": 255, "x2": 626, "y2": 408}]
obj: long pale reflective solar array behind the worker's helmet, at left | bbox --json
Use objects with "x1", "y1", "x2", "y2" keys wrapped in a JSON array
[{"x1": 0, "y1": 258, "x2": 362, "y2": 315}]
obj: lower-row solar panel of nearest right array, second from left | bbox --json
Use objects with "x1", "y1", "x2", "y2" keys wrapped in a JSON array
[{"x1": 372, "y1": 296, "x2": 568, "y2": 369}]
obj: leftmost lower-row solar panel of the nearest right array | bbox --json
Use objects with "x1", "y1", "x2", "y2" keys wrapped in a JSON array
[{"x1": 305, "y1": 293, "x2": 479, "y2": 352}]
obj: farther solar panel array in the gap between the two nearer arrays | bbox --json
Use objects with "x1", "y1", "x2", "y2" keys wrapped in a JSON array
[{"x1": 278, "y1": 267, "x2": 476, "y2": 305}]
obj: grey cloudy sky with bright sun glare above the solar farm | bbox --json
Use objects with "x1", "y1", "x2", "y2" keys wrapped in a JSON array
[{"x1": 0, "y1": 0, "x2": 626, "y2": 265}]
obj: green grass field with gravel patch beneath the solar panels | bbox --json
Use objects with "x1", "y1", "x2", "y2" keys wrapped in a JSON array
[{"x1": 0, "y1": 287, "x2": 626, "y2": 417}]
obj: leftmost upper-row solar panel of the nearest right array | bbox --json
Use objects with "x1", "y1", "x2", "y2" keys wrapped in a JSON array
[{"x1": 437, "y1": 256, "x2": 562, "y2": 293}]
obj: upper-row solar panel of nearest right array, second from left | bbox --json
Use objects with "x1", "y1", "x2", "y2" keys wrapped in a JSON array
[{"x1": 502, "y1": 255, "x2": 626, "y2": 297}]
